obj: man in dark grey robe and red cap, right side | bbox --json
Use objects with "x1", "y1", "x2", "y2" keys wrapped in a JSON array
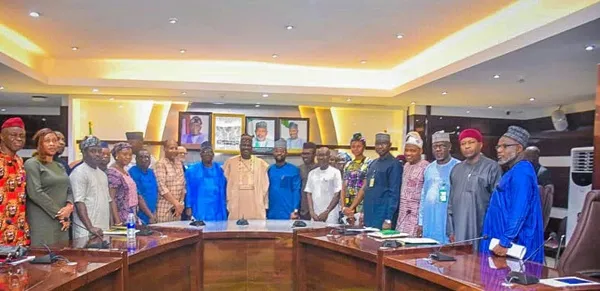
[{"x1": 446, "y1": 129, "x2": 502, "y2": 250}]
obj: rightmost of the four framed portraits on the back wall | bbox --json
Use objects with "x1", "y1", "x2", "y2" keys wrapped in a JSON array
[{"x1": 278, "y1": 117, "x2": 310, "y2": 153}]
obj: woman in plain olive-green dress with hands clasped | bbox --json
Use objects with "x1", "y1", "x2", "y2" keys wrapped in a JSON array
[{"x1": 25, "y1": 128, "x2": 73, "y2": 246}]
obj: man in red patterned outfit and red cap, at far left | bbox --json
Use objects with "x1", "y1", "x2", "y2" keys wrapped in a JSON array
[{"x1": 0, "y1": 117, "x2": 29, "y2": 246}]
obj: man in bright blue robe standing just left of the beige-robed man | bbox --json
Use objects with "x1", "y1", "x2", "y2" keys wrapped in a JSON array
[{"x1": 185, "y1": 141, "x2": 227, "y2": 221}]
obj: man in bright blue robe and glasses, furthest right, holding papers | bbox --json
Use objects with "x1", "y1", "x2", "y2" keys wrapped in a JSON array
[{"x1": 480, "y1": 126, "x2": 544, "y2": 263}]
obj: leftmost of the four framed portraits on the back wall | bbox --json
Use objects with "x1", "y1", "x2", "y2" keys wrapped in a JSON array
[{"x1": 178, "y1": 112, "x2": 212, "y2": 150}]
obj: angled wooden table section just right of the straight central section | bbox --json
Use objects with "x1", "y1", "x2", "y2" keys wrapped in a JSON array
[{"x1": 294, "y1": 230, "x2": 471, "y2": 290}]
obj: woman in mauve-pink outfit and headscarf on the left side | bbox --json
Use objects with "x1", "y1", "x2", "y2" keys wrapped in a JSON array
[{"x1": 106, "y1": 142, "x2": 138, "y2": 225}]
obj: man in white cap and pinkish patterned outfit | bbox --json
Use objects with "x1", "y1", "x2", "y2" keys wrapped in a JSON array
[{"x1": 396, "y1": 131, "x2": 429, "y2": 236}]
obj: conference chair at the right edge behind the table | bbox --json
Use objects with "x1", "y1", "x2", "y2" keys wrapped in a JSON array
[{"x1": 557, "y1": 190, "x2": 600, "y2": 277}]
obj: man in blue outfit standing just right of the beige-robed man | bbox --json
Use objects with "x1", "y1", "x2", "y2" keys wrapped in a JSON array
[{"x1": 267, "y1": 139, "x2": 302, "y2": 219}]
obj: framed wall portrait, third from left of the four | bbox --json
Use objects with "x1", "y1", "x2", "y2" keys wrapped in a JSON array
[{"x1": 246, "y1": 116, "x2": 278, "y2": 154}]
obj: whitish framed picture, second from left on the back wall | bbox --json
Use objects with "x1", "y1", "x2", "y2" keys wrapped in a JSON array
[{"x1": 212, "y1": 113, "x2": 246, "y2": 154}]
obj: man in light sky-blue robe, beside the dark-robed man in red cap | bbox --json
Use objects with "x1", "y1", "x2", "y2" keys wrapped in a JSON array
[{"x1": 417, "y1": 131, "x2": 460, "y2": 244}]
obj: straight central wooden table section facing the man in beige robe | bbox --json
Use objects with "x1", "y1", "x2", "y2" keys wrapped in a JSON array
[{"x1": 155, "y1": 220, "x2": 327, "y2": 291}]
